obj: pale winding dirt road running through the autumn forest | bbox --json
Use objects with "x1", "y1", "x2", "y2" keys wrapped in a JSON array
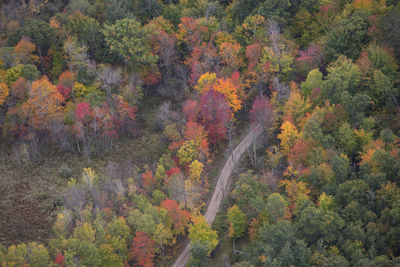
[{"x1": 172, "y1": 125, "x2": 263, "y2": 267}]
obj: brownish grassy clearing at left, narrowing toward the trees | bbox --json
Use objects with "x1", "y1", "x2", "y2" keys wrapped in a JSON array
[{"x1": 0, "y1": 100, "x2": 167, "y2": 246}]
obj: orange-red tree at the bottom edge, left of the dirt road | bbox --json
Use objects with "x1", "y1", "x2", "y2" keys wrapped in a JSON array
[{"x1": 130, "y1": 231, "x2": 155, "y2": 267}]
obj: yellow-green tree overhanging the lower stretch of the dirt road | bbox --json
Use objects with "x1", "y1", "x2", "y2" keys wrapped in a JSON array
[{"x1": 189, "y1": 215, "x2": 218, "y2": 255}]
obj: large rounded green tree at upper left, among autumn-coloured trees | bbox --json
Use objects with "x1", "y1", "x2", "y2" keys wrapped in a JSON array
[{"x1": 103, "y1": 19, "x2": 157, "y2": 67}]
